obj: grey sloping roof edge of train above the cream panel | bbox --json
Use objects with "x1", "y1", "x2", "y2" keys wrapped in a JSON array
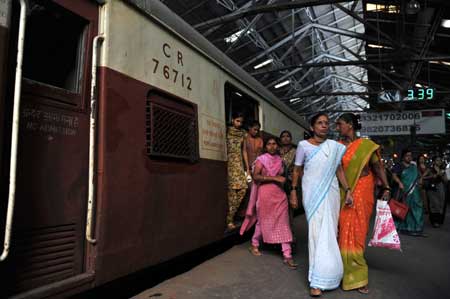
[{"x1": 109, "y1": 0, "x2": 309, "y2": 129}]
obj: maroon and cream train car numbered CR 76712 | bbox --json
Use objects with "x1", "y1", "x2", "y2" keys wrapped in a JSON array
[{"x1": 0, "y1": 0, "x2": 306, "y2": 298}]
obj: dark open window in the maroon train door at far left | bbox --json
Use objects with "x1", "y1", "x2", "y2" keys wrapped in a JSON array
[{"x1": 23, "y1": 0, "x2": 88, "y2": 93}]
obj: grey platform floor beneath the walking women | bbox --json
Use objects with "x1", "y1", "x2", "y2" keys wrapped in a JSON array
[{"x1": 133, "y1": 209, "x2": 450, "y2": 299}]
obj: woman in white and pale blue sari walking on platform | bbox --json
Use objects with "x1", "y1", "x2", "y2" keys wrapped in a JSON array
[{"x1": 290, "y1": 113, "x2": 353, "y2": 297}]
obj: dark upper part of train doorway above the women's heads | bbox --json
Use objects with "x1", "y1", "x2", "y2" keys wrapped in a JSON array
[{"x1": 225, "y1": 82, "x2": 259, "y2": 129}]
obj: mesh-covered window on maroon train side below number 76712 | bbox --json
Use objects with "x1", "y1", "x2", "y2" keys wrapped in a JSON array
[{"x1": 146, "y1": 91, "x2": 199, "y2": 162}]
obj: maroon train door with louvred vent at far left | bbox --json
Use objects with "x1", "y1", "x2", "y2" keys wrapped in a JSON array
[{"x1": 0, "y1": 0, "x2": 99, "y2": 297}]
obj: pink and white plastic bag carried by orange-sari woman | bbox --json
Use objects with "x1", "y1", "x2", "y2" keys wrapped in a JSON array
[{"x1": 369, "y1": 200, "x2": 402, "y2": 251}]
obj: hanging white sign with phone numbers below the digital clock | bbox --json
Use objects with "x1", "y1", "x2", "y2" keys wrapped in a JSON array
[{"x1": 361, "y1": 109, "x2": 445, "y2": 136}]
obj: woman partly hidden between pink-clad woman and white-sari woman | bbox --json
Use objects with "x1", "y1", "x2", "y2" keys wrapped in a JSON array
[{"x1": 280, "y1": 130, "x2": 296, "y2": 246}]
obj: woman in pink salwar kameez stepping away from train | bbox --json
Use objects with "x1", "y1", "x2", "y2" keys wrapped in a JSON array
[{"x1": 241, "y1": 138, "x2": 297, "y2": 269}]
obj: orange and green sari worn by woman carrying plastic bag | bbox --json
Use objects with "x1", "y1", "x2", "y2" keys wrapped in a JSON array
[{"x1": 339, "y1": 139, "x2": 380, "y2": 290}]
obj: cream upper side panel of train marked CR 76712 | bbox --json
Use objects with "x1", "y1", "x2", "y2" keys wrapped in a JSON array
[{"x1": 101, "y1": 1, "x2": 303, "y2": 161}]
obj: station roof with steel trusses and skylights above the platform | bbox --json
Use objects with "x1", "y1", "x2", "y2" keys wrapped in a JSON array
[{"x1": 162, "y1": 0, "x2": 450, "y2": 122}]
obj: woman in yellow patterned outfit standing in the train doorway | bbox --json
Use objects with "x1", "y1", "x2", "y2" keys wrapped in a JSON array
[{"x1": 227, "y1": 112, "x2": 250, "y2": 230}]
